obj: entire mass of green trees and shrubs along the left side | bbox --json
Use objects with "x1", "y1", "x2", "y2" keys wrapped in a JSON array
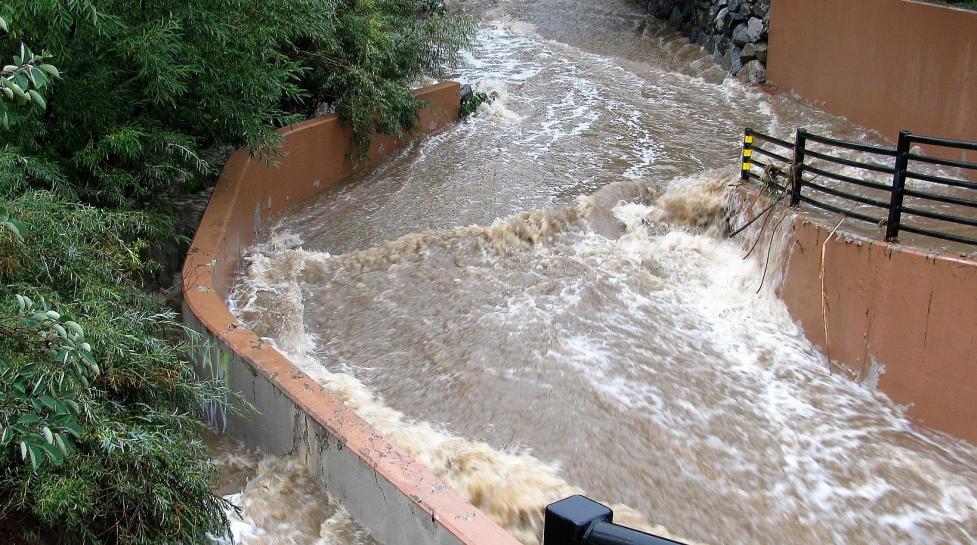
[{"x1": 0, "y1": 0, "x2": 473, "y2": 545}]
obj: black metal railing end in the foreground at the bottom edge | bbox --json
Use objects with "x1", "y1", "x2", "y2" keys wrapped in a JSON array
[{"x1": 543, "y1": 496, "x2": 684, "y2": 545}]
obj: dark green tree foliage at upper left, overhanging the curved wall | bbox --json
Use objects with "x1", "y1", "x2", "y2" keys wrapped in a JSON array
[{"x1": 0, "y1": 0, "x2": 473, "y2": 207}]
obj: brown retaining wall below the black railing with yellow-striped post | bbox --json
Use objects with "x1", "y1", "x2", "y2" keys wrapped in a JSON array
[{"x1": 740, "y1": 190, "x2": 977, "y2": 444}]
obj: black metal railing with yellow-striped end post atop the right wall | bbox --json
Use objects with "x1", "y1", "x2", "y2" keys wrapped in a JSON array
[{"x1": 742, "y1": 129, "x2": 977, "y2": 245}]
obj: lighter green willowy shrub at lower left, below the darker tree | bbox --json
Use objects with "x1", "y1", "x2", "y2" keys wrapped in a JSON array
[{"x1": 0, "y1": 191, "x2": 230, "y2": 545}]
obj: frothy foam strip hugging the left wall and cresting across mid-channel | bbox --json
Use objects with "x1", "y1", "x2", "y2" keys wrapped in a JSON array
[{"x1": 233, "y1": 215, "x2": 684, "y2": 545}]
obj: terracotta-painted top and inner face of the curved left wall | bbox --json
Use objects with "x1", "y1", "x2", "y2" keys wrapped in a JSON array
[{"x1": 183, "y1": 82, "x2": 518, "y2": 545}]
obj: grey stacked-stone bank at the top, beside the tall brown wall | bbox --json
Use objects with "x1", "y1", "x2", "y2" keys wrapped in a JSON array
[{"x1": 647, "y1": 0, "x2": 771, "y2": 83}]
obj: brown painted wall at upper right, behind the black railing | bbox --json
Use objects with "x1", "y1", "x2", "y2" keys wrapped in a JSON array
[{"x1": 767, "y1": 0, "x2": 977, "y2": 167}]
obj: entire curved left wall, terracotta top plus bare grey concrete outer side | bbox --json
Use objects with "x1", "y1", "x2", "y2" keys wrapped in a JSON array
[{"x1": 183, "y1": 83, "x2": 518, "y2": 545}]
